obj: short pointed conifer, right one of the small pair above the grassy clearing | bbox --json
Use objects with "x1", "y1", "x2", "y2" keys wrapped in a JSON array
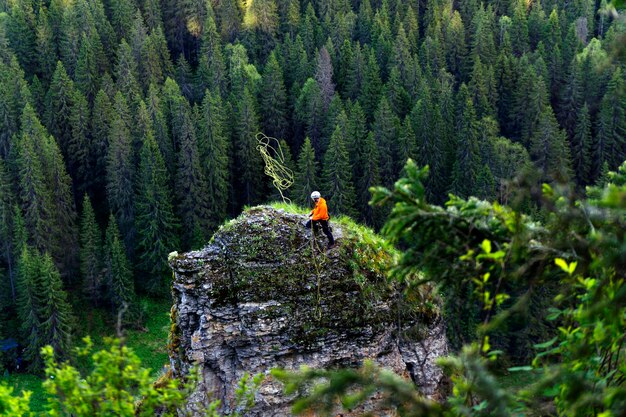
[{"x1": 104, "y1": 214, "x2": 135, "y2": 312}]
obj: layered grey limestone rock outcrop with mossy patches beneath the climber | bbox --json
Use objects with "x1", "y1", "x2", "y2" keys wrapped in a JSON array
[{"x1": 170, "y1": 207, "x2": 448, "y2": 416}]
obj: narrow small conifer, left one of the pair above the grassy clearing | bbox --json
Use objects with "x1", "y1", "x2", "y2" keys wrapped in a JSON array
[{"x1": 80, "y1": 194, "x2": 103, "y2": 305}]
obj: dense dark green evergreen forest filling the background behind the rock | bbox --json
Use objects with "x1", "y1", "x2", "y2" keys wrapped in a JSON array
[{"x1": 0, "y1": 0, "x2": 626, "y2": 380}]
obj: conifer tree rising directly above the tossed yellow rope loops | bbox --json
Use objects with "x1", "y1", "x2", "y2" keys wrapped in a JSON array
[{"x1": 259, "y1": 52, "x2": 287, "y2": 139}]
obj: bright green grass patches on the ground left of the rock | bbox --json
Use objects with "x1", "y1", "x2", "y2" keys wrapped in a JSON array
[{"x1": 0, "y1": 298, "x2": 171, "y2": 413}]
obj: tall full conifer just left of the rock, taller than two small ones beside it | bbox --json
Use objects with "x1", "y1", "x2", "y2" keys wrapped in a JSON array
[{"x1": 135, "y1": 102, "x2": 178, "y2": 292}]
